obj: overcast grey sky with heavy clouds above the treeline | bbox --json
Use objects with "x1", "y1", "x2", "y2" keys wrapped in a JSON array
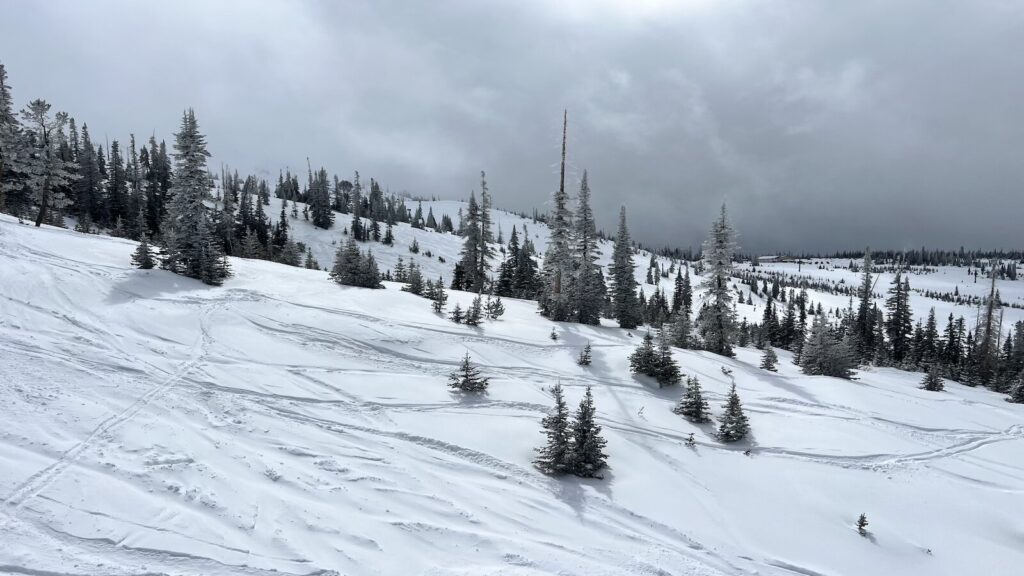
[{"x1": 0, "y1": 0, "x2": 1024, "y2": 251}]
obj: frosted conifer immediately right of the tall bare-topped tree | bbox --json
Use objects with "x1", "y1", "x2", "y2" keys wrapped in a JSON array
[{"x1": 572, "y1": 170, "x2": 605, "y2": 325}]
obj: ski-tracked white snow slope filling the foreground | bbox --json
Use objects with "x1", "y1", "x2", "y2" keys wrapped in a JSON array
[{"x1": 0, "y1": 212, "x2": 1024, "y2": 576}]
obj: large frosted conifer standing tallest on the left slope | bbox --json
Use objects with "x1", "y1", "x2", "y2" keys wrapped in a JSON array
[{"x1": 161, "y1": 109, "x2": 230, "y2": 284}]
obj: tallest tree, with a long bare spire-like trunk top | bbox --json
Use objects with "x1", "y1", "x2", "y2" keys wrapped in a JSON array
[{"x1": 540, "y1": 112, "x2": 573, "y2": 321}]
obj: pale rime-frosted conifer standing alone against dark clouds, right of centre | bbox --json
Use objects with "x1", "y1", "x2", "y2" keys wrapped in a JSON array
[{"x1": 697, "y1": 204, "x2": 737, "y2": 356}]
